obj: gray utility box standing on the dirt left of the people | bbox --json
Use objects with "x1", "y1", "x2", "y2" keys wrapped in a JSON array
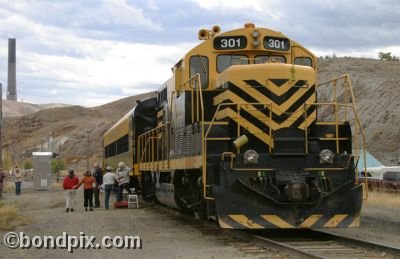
[{"x1": 32, "y1": 152, "x2": 53, "y2": 191}]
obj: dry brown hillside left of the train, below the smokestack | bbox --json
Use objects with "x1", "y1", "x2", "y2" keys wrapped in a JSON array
[{"x1": 3, "y1": 94, "x2": 155, "y2": 168}]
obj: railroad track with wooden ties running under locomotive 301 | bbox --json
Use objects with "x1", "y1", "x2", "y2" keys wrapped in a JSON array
[{"x1": 144, "y1": 205, "x2": 400, "y2": 258}]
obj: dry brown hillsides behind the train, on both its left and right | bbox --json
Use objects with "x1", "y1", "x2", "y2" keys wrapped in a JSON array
[{"x1": 4, "y1": 58, "x2": 400, "y2": 168}]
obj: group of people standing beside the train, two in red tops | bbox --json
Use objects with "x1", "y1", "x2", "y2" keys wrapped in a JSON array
[{"x1": 63, "y1": 162, "x2": 131, "y2": 212}]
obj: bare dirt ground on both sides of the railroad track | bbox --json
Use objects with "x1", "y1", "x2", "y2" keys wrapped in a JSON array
[{"x1": 0, "y1": 182, "x2": 400, "y2": 258}]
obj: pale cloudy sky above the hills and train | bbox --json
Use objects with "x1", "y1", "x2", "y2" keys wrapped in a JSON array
[{"x1": 0, "y1": 0, "x2": 400, "y2": 107}]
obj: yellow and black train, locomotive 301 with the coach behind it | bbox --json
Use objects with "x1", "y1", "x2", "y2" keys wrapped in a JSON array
[{"x1": 103, "y1": 23, "x2": 363, "y2": 229}]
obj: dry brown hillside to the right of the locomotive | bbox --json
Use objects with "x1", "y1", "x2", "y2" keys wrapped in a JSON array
[{"x1": 319, "y1": 58, "x2": 400, "y2": 165}]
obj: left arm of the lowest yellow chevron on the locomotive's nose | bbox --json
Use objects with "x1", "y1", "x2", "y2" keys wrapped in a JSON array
[{"x1": 216, "y1": 108, "x2": 274, "y2": 148}]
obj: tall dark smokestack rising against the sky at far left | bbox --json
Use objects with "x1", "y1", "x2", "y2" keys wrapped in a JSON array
[{"x1": 7, "y1": 39, "x2": 17, "y2": 101}]
